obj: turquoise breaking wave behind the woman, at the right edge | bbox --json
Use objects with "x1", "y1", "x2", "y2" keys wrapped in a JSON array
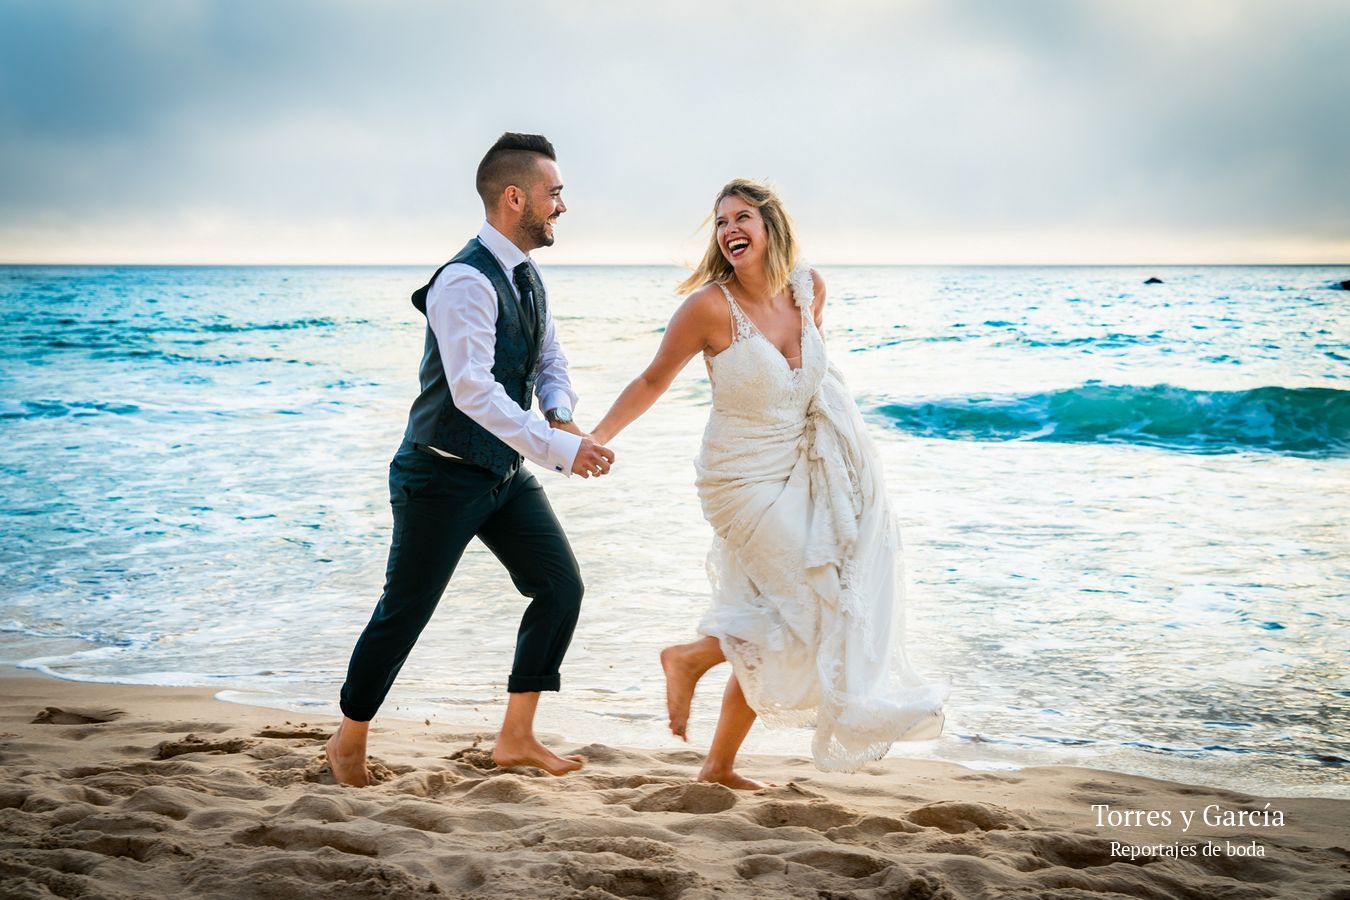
[{"x1": 878, "y1": 382, "x2": 1350, "y2": 457}]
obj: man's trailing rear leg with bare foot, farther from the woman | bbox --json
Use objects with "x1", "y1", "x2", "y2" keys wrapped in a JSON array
[{"x1": 325, "y1": 448, "x2": 497, "y2": 787}]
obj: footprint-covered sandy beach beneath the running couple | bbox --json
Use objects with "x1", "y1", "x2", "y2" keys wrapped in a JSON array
[{"x1": 0, "y1": 671, "x2": 1350, "y2": 900}]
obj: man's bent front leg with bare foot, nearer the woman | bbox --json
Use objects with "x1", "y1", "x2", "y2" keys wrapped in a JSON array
[{"x1": 478, "y1": 471, "x2": 585, "y2": 775}]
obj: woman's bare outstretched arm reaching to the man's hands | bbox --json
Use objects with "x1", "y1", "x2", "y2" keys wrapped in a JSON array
[{"x1": 591, "y1": 285, "x2": 728, "y2": 444}]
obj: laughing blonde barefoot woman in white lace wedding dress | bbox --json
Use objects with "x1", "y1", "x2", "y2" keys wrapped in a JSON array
[{"x1": 591, "y1": 178, "x2": 945, "y2": 789}]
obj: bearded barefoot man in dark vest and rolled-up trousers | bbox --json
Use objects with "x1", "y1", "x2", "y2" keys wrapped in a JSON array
[{"x1": 325, "y1": 134, "x2": 614, "y2": 787}]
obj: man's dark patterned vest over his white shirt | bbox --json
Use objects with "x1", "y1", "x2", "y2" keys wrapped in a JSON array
[{"x1": 404, "y1": 237, "x2": 548, "y2": 475}]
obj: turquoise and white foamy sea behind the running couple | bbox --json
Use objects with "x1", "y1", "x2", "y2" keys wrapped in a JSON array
[{"x1": 0, "y1": 260, "x2": 1350, "y2": 796}]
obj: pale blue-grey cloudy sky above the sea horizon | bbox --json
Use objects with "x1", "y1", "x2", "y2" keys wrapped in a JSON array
[{"x1": 0, "y1": 0, "x2": 1350, "y2": 263}]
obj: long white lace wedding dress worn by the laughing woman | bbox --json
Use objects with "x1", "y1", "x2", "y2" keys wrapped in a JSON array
[{"x1": 695, "y1": 266, "x2": 946, "y2": 770}]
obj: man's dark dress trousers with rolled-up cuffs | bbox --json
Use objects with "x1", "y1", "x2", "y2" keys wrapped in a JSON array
[{"x1": 342, "y1": 441, "x2": 582, "y2": 722}]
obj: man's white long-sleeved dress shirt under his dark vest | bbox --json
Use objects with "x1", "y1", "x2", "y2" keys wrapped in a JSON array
[{"x1": 427, "y1": 221, "x2": 582, "y2": 475}]
